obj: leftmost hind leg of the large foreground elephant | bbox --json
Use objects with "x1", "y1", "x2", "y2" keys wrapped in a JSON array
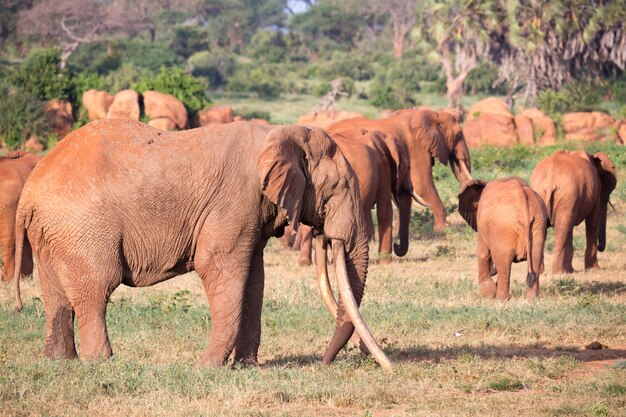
[{"x1": 39, "y1": 266, "x2": 78, "y2": 359}]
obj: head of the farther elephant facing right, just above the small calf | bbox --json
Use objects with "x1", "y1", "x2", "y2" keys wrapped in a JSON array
[{"x1": 411, "y1": 110, "x2": 472, "y2": 184}]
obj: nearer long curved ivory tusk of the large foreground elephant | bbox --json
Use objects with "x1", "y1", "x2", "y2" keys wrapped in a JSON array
[{"x1": 332, "y1": 240, "x2": 392, "y2": 370}]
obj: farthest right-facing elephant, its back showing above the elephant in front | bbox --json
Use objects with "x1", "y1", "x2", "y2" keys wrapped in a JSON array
[{"x1": 326, "y1": 110, "x2": 472, "y2": 232}]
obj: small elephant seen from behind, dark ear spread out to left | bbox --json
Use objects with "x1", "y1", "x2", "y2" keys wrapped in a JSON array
[{"x1": 459, "y1": 177, "x2": 547, "y2": 300}]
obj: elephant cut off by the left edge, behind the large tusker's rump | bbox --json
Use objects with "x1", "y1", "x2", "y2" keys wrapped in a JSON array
[{"x1": 0, "y1": 151, "x2": 41, "y2": 281}]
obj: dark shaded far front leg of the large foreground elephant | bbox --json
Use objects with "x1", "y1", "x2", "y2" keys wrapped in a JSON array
[{"x1": 234, "y1": 240, "x2": 266, "y2": 365}]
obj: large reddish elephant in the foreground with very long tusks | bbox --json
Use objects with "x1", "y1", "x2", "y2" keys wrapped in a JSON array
[{"x1": 15, "y1": 120, "x2": 391, "y2": 367}]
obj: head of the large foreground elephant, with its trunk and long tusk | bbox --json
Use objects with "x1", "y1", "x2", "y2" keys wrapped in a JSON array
[{"x1": 258, "y1": 126, "x2": 391, "y2": 367}]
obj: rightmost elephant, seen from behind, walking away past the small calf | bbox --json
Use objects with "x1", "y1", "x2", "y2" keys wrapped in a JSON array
[{"x1": 530, "y1": 151, "x2": 617, "y2": 273}]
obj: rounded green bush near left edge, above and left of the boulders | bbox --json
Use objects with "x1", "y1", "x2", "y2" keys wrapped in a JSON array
[{"x1": 7, "y1": 49, "x2": 72, "y2": 100}]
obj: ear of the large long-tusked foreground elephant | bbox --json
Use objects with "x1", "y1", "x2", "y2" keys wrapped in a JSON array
[{"x1": 257, "y1": 126, "x2": 311, "y2": 233}]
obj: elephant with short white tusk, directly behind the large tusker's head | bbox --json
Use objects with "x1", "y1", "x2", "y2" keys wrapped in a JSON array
[{"x1": 295, "y1": 129, "x2": 428, "y2": 265}]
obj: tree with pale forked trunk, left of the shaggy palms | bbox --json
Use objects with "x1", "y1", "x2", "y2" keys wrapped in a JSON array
[{"x1": 418, "y1": 0, "x2": 502, "y2": 108}]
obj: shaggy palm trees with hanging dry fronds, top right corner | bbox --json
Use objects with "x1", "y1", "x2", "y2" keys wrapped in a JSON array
[{"x1": 493, "y1": 0, "x2": 626, "y2": 105}]
